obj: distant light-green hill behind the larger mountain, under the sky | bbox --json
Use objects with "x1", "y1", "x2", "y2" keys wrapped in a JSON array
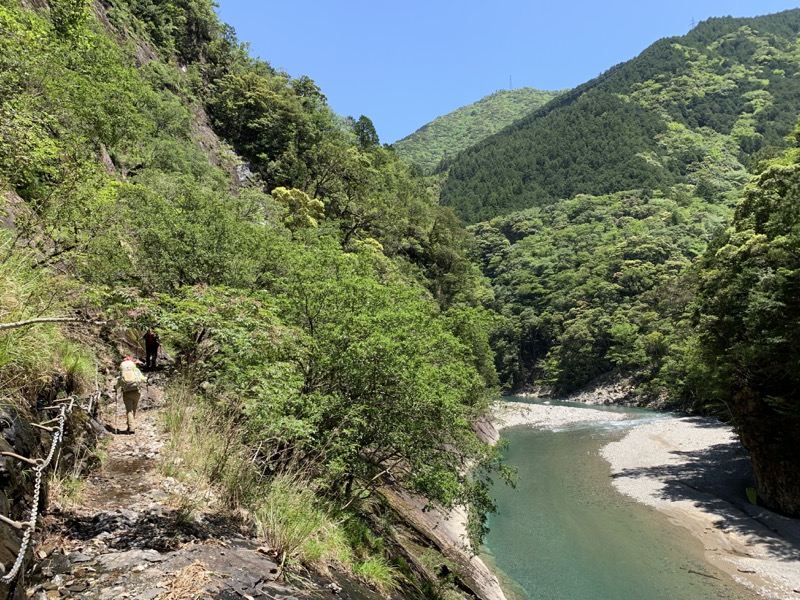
[{"x1": 392, "y1": 87, "x2": 563, "y2": 173}]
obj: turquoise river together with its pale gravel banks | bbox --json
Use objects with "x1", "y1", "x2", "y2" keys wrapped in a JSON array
[{"x1": 484, "y1": 398, "x2": 800, "y2": 600}]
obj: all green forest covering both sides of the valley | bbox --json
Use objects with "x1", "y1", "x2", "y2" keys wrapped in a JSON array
[{"x1": 0, "y1": 0, "x2": 800, "y2": 597}]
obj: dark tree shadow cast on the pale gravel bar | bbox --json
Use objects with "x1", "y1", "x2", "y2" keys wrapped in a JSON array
[{"x1": 612, "y1": 419, "x2": 800, "y2": 560}]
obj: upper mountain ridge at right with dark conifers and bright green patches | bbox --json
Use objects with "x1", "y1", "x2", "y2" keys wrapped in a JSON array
[{"x1": 442, "y1": 10, "x2": 800, "y2": 222}]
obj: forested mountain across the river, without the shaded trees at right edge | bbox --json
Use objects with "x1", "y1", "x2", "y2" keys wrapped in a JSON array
[{"x1": 462, "y1": 10, "x2": 800, "y2": 397}]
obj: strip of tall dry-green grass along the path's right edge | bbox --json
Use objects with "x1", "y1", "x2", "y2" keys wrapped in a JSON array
[{"x1": 162, "y1": 376, "x2": 401, "y2": 595}]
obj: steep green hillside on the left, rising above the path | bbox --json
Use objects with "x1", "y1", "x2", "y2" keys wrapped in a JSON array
[{"x1": 0, "y1": 0, "x2": 506, "y2": 590}]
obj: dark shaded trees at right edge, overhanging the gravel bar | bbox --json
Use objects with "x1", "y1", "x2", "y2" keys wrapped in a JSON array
[{"x1": 695, "y1": 134, "x2": 800, "y2": 516}]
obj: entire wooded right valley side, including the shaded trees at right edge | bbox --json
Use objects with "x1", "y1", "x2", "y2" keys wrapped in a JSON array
[{"x1": 432, "y1": 10, "x2": 800, "y2": 515}]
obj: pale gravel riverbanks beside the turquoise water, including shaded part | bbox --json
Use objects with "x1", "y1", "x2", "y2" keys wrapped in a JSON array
[{"x1": 494, "y1": 402, "x2": 800, "y2": 600}]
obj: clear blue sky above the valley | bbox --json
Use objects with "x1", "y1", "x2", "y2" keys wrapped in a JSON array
[{"x1": 217, "y1": 0, "x2": 800, "y2": 143}]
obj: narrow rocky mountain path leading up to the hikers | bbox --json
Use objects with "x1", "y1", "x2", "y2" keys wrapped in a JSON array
[{"x1": 23, "y1": 376, "x2": 366, "y2": 600}]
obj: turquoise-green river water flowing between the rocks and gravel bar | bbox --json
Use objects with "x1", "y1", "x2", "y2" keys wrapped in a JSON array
[{"x1": 484, "y1": 404, "x2": 756, "y2": 600}]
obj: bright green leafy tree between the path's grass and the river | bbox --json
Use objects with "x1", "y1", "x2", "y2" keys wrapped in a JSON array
[{"x1": 265, "y1": 238, "x2": 504, "y2": 540}]
